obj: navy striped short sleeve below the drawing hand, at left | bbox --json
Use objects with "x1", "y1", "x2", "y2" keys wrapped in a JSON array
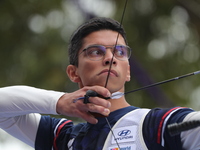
[{"x1": 35, "y1": 116, "x2": 73, "y2": 150}]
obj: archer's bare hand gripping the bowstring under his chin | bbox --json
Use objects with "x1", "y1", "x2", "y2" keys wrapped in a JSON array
[{"x1": 56, "y1": 86, "x2": 111, "y2": 124}]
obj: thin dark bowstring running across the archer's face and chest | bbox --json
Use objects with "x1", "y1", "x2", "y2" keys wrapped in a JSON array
[{"x1": 104, "y1": 0, "x2": 128, "y2": 149}]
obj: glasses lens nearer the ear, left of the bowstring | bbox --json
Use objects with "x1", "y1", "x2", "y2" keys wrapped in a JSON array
[{"x1": 86, "y1": 45, "x2": 106, "y2": 60}]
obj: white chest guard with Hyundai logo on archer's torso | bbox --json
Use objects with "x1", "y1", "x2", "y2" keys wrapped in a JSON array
[{"x1": 103, "y1": 109, "x2": 150, "y2": 150}]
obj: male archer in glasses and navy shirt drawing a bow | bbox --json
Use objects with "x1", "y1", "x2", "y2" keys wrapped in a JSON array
[{"x1": 0, "y1": 18, "x2": 200, "y2": 150}]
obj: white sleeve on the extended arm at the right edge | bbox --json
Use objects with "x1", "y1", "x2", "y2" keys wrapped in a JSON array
[{"x1": 181, "y1": 111, "x2": 200, "y2": 150}]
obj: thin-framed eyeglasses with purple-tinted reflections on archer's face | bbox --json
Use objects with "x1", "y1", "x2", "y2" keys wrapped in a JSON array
[{"x1": 79, "y1": 45, "x2": 131, "y2": 61}]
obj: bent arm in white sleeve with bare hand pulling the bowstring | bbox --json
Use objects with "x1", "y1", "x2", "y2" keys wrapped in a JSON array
[{"x1": 0, "y1": 86, "x2": 110, "y2": 147}]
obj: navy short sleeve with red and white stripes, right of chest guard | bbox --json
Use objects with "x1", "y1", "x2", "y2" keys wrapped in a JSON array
[{"x1": 143, "y1": 107, "x2": 193, "y2": 150}]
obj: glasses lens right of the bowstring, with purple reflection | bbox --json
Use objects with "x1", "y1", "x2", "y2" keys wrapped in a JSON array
[{"x1": 115, "y1": 45, "x2": 131, "y2": 60}]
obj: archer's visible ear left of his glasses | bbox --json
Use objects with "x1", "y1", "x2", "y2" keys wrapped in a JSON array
[{"x1": 66, "y1": 65, "x2": 80, "y2": 83}]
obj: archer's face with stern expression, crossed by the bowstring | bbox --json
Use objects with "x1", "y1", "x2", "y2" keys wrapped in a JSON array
[{"x1": 68, "y1": 30, "x2": 130, "y2": 93}]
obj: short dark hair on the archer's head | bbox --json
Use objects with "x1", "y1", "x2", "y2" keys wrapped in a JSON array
[{"x1": 68, "y1": 17, "x2": 127, "y2": 66}]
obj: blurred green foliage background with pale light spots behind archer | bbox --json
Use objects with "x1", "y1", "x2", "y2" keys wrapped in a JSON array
[{"x1": 0, "y1": 0, "x2": 200, "y2": 150}]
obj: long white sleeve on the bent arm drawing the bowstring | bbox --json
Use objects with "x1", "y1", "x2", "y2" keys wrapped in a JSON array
[{"x1": 0, "y1": 86, "x2": 64, "y2": 147}]
